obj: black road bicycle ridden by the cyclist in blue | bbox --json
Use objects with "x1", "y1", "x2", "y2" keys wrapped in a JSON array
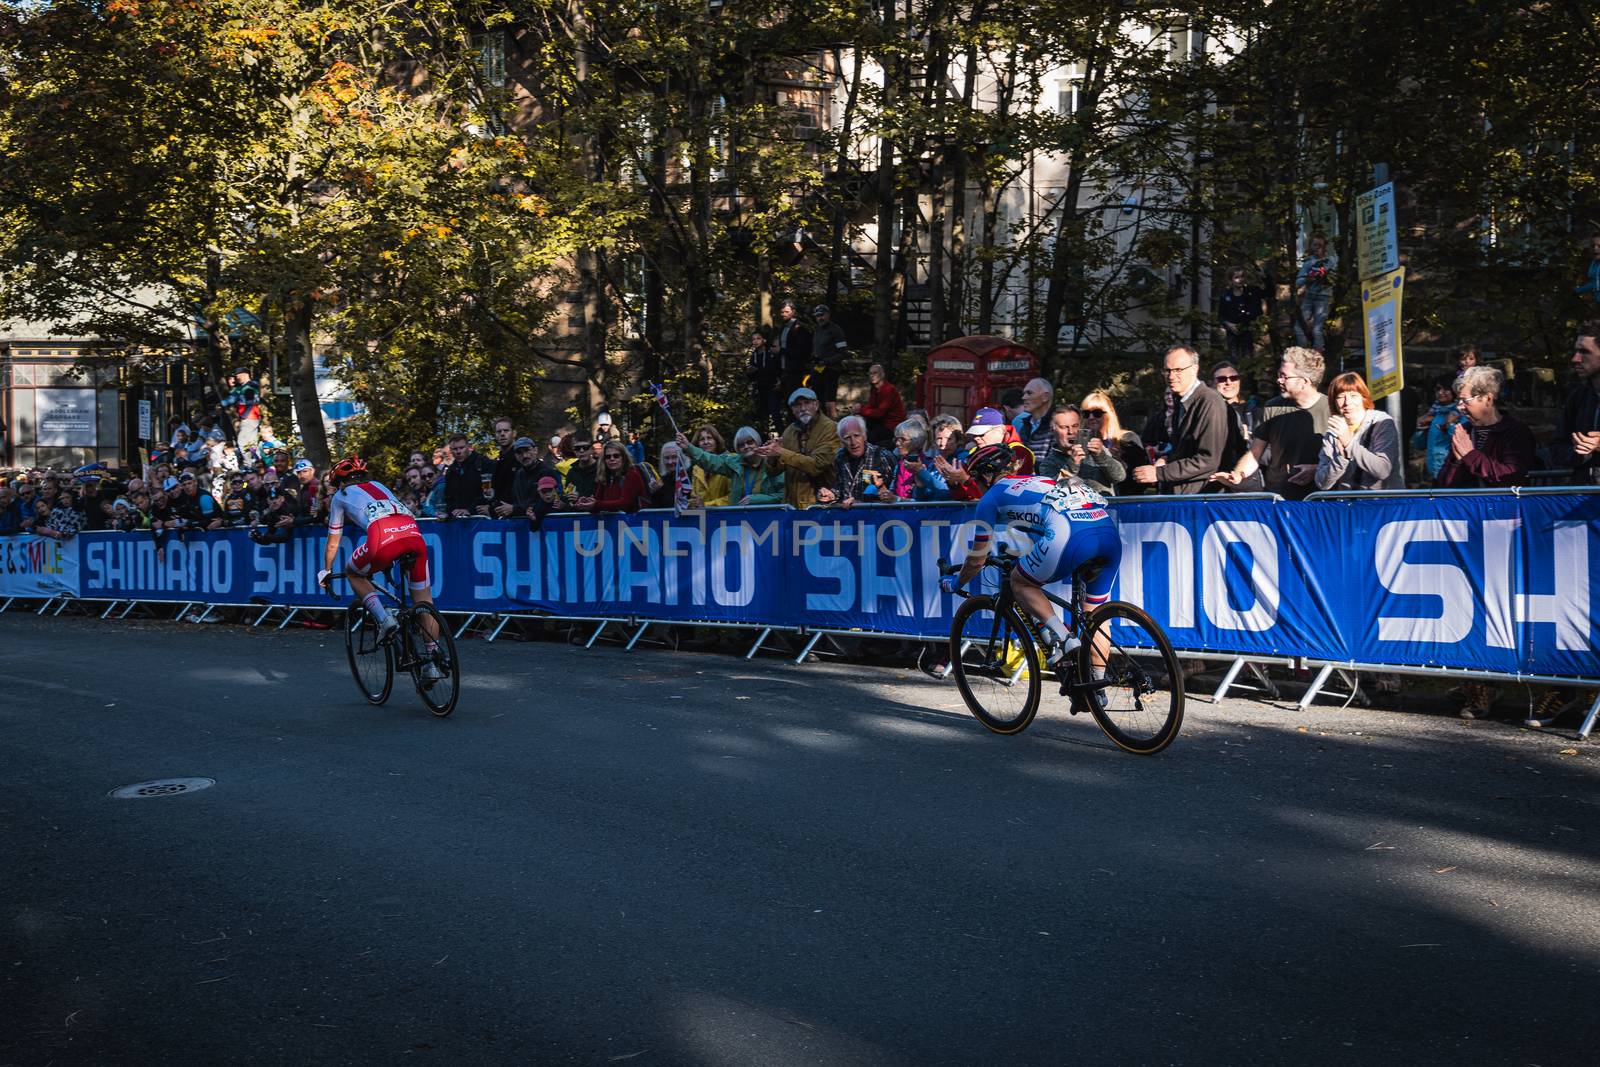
[{"x1": 939, "y1": 552, "x2": 1184, "y2": 755}]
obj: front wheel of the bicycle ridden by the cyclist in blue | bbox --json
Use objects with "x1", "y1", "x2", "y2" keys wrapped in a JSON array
[{"x1": 950, "y1": 597, "x2": 1042, "y2": 734}]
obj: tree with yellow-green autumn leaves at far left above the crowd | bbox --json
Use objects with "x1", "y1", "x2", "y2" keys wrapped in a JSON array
[{"x1": 0, "y1": 0, "x2": 603, "y2": 464}]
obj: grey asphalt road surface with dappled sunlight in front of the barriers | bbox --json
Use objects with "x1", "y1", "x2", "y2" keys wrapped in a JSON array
[{"x1": 0, "y1": 614, "x2": 1600, "y2": 1067}]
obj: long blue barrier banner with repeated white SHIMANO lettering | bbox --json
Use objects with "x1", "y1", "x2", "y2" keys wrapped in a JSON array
[{"x1": 68, "y1": 493, "x2": 1600, "y2": 678}]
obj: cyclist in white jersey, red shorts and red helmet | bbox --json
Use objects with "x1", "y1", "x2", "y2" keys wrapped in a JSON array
[{"x1": 317, "y1": 456, "x2": 443, "y2": 680}]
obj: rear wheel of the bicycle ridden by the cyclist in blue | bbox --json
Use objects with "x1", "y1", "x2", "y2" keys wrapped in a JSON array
[{"x1": 1078, "y1": 600, "x2": 1184, "y2": 755}]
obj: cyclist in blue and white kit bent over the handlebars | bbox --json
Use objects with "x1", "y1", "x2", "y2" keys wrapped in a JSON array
[{"x1": 939, "y1": 445, "x2": 1122, "y2": 667}]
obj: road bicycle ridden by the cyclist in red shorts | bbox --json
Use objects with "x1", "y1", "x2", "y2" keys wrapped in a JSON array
[{"x1": 328, "y1": 552, "x2": 461, "y2": 718}]
